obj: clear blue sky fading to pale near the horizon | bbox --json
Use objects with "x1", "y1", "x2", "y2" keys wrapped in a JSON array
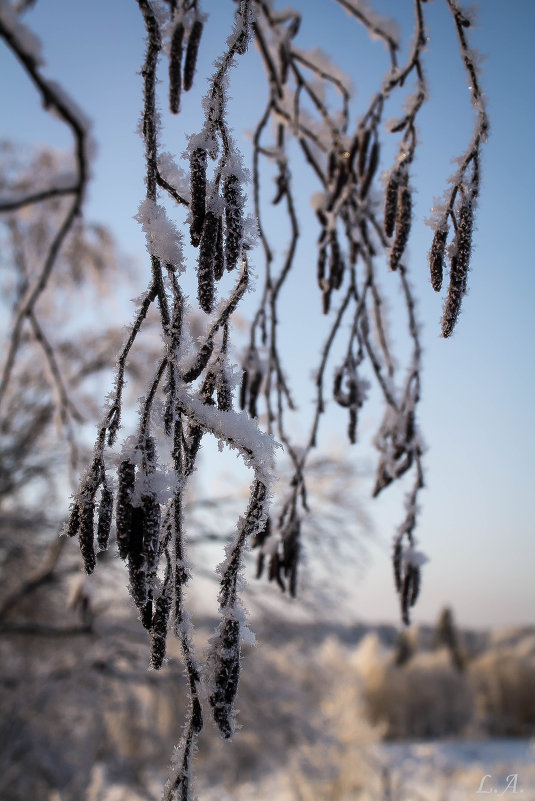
[{"x1": 0, "y1": 0, "x2": 535, "y2": 625}]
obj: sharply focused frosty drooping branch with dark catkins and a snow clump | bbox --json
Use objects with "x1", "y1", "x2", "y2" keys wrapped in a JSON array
[{"x1": 67, "y1": 0, "x2": 274, "y2": 801}]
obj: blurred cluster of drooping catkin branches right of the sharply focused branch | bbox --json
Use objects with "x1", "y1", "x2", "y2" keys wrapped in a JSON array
[{"x1": 245, "y1": 0, "x2": 426, "y2": 620}]
